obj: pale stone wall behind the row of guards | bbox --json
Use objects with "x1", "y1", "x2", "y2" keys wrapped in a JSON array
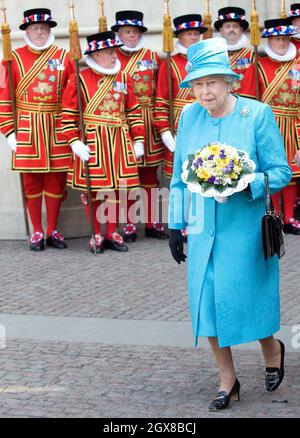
[{"x1": 0, "y1": 0, "x2": 293, "y2": 239}]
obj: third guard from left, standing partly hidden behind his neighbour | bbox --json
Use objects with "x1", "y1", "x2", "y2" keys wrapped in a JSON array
[{"x1": 111, "y1": 10, "x2": 167, "y2": 241}]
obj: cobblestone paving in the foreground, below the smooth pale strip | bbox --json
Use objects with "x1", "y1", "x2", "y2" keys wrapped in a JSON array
[{"x1": 0, "y1": 340, "x2": 300, "y2": 418}]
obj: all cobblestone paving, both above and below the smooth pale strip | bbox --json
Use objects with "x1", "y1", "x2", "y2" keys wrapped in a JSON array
[{"x1": 0, "y1": 236, "x2": 300, "y2": 418}]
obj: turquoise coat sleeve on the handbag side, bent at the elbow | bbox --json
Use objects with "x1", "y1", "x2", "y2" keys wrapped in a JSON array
[{"x1": 249, "y1": 104, "x2": 292, "y2": 200}]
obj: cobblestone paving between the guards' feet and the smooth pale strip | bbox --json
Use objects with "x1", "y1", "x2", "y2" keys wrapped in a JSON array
[{"x1": 0, "y1": 235, "x2": 300, "y2": 324}]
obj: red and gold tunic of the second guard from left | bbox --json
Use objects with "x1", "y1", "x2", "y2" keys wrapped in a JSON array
[{"x1": 63, "y1": 68, "x2": 144, "y2": 191}]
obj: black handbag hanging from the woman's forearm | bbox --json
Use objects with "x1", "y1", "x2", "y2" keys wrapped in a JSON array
[{"x1": 262, "y1": 174, "x2": 285, "y2": 259}]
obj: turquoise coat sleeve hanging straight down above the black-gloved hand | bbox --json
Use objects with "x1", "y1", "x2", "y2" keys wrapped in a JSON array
[{"x1": 169, "y1": 106, "x2": 190, "y2": 230}]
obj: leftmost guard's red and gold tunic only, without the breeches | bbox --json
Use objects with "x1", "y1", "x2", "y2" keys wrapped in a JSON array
[{"x1": 0, "y1": 45, "x2": 74, "y2": 173}]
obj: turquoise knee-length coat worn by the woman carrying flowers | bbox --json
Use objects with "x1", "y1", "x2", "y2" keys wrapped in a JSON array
[{"x1": 169, "y1": 97, "x2": 292, "y2": 347}]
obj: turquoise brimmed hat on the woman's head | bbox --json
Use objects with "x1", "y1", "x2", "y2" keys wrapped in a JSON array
[{"x1": 180, "y1": 38, "x2": 240, "y2": 88}]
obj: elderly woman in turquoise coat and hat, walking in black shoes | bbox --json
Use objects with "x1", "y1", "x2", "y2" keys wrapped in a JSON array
[{"x1": 169, "y1": 38, "x2": 291, "y2": 411}]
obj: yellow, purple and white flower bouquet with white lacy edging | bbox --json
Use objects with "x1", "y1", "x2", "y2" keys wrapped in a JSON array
[{"x1": 181, "y1": 142, "x2": 255, "y2": 202}]
